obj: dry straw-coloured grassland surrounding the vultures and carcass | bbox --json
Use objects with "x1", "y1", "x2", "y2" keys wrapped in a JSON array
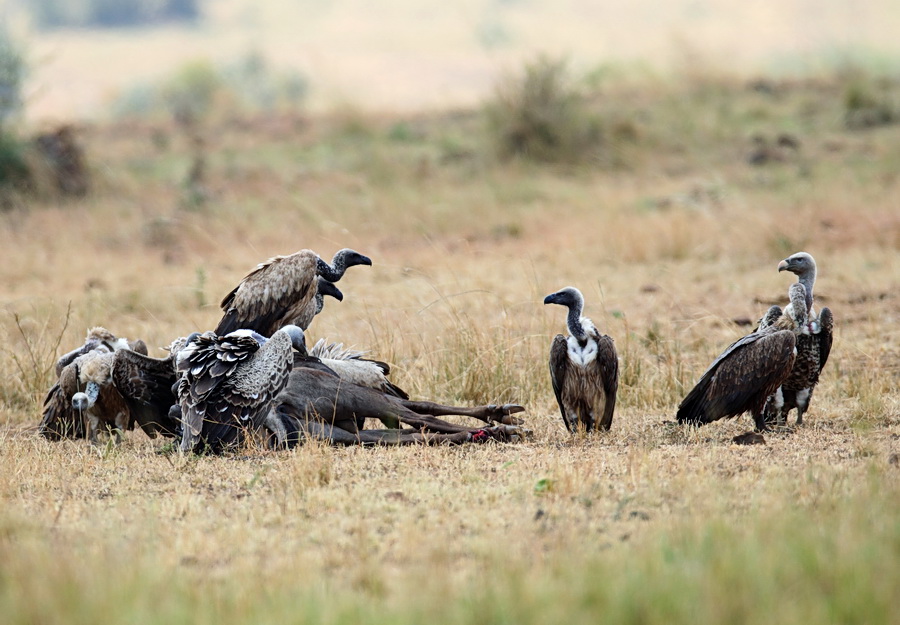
[{"x1": 0, "y1": 62, "x2": 900, "y2": 623}]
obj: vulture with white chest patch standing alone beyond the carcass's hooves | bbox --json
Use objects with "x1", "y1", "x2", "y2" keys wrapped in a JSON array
[{"x1": 544, "y1": 286, "x2": 619, "y2": 433}]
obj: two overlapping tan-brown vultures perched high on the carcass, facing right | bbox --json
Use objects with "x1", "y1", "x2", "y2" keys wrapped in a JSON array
[{"x1": 215, "y1": 249, "x2": 372, "y2": 337}]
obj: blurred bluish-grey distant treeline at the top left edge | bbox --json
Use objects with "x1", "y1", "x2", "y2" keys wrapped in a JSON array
[{"x1": 28, "y1": 0, "x2": 200, "y2": 28}]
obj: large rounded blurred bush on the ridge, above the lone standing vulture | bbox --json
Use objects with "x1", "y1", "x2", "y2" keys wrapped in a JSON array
[{"x1": 485, "y1": 58, "x2": 602, "y2": 162}]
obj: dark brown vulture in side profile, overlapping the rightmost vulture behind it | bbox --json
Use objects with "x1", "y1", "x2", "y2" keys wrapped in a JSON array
[{"x1": 677, "y1": 283, "x2": 806, "y2": 430}]
